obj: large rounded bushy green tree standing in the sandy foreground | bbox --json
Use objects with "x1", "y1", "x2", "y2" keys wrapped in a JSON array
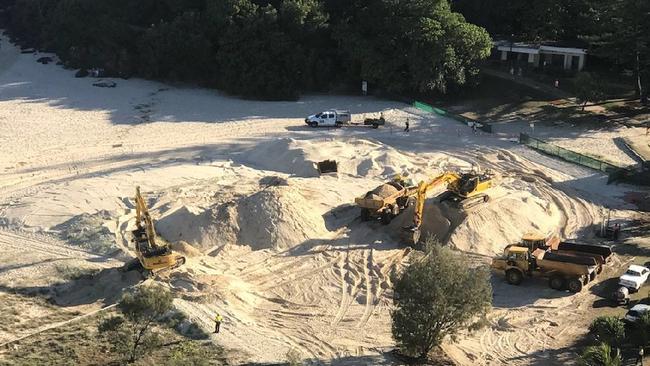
[{"x1": 391, "y1": 240, "x2": 492, "y2": 358}]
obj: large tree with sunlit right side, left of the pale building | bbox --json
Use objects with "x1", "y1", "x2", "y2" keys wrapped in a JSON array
[{"x1": 334, "y1": 0, "x2": 492, "y2": 93}]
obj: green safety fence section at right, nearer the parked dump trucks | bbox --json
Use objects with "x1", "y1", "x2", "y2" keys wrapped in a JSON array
[{"x1": 519, "y1": 133, "x2": 628, "y2": 183}]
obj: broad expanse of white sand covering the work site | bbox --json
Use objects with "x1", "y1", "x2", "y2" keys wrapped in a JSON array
[{"x1": 0, "y1": 35, "x2": 644, "y2": 364}]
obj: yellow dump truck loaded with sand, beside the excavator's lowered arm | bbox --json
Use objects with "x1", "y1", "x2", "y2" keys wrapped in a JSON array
[{"x1": 354, "y1": 176, "x2": 417, "y2": 225}]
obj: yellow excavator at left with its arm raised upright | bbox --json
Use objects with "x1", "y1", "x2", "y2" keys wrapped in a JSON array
[{"x1": 123, "y1": 186, "x2": 185, "y2": 273}]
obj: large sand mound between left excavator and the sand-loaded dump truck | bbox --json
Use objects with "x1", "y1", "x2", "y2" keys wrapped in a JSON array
[{"x1": 156, "y1": 186, "x2": 328, "y2": 250}]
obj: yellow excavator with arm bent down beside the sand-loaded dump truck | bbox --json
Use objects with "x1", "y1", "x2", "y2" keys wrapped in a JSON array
[{"x1": 404, "y1": 171, "x2": 494, "y2": 245}]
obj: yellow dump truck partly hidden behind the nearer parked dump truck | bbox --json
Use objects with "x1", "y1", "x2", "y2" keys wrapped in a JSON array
[{"x1": 521, "y1": 232, "x2": 612, "y2": 273}]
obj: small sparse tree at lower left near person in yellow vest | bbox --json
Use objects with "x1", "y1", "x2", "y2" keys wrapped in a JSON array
[{"x1": 98, "y1": 286, "x2": 173, "y2": 362}]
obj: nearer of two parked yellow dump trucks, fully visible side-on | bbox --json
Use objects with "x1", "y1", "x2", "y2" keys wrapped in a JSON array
[{"x1": 491, "y1": 245, "x2": 598, "y2": 293}]
